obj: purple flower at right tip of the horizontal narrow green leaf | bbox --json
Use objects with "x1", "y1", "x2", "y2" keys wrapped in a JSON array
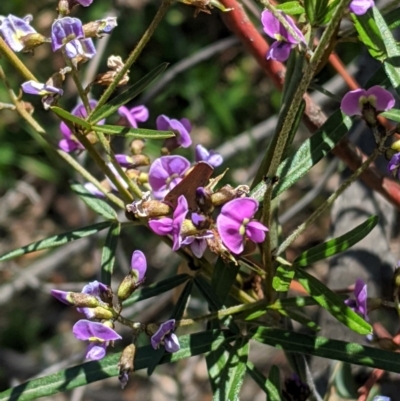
[{"x1": 156, "y1": 114, "x2": 192, "y2": 151}]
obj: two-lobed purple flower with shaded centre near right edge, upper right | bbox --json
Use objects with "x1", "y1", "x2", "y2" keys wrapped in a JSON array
[{"x1": 340, "y1": 85, "x2": 395, "y2": 116}]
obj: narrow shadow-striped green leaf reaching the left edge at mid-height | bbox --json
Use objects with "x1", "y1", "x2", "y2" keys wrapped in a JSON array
[{"x1": 0, "y1": 221, "x2": 111, "y2": 262}]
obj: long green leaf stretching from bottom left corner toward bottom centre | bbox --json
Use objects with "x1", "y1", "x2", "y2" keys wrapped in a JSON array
[{"x1": 0, "y1": 330, "x2": 235, "y2": 401}]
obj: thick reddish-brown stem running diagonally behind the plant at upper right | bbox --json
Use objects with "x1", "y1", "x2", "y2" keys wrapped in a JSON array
[{"x1": 221, "y1": 0, "x2": 400, "y2": 209}]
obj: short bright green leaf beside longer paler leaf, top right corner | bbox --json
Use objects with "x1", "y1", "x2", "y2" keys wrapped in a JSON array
[{"x1": 350, "y1": 11, "x2": 387, "y2": 61}]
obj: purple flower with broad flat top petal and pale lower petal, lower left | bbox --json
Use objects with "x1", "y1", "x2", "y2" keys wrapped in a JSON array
[{"x1": 72, "y1": 319, "x2": 122, "y2": 361}]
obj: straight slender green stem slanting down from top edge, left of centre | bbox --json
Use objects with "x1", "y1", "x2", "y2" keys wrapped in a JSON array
[{"x1": 89, "y1": 0, "x2": 173, "y2": 119}]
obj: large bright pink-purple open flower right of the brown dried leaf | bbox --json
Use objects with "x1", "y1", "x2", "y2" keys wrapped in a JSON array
[{"x1": 217, "y1": 198, "x2": 268, "y2": 254}]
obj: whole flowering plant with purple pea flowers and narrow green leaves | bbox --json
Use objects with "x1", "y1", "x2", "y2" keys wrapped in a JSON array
[{"x1": 0, "y1": 0, "x2": 400, "y2": 401}]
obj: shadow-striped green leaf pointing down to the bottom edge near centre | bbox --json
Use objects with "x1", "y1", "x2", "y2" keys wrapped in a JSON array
[{"x1": 209, "y1": 338, "x2": 249, "y2": 401}]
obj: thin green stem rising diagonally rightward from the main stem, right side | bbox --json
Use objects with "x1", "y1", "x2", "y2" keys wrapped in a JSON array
[{"x1": 276, "y1": 142, "x2": 382, "y2": 255}]
